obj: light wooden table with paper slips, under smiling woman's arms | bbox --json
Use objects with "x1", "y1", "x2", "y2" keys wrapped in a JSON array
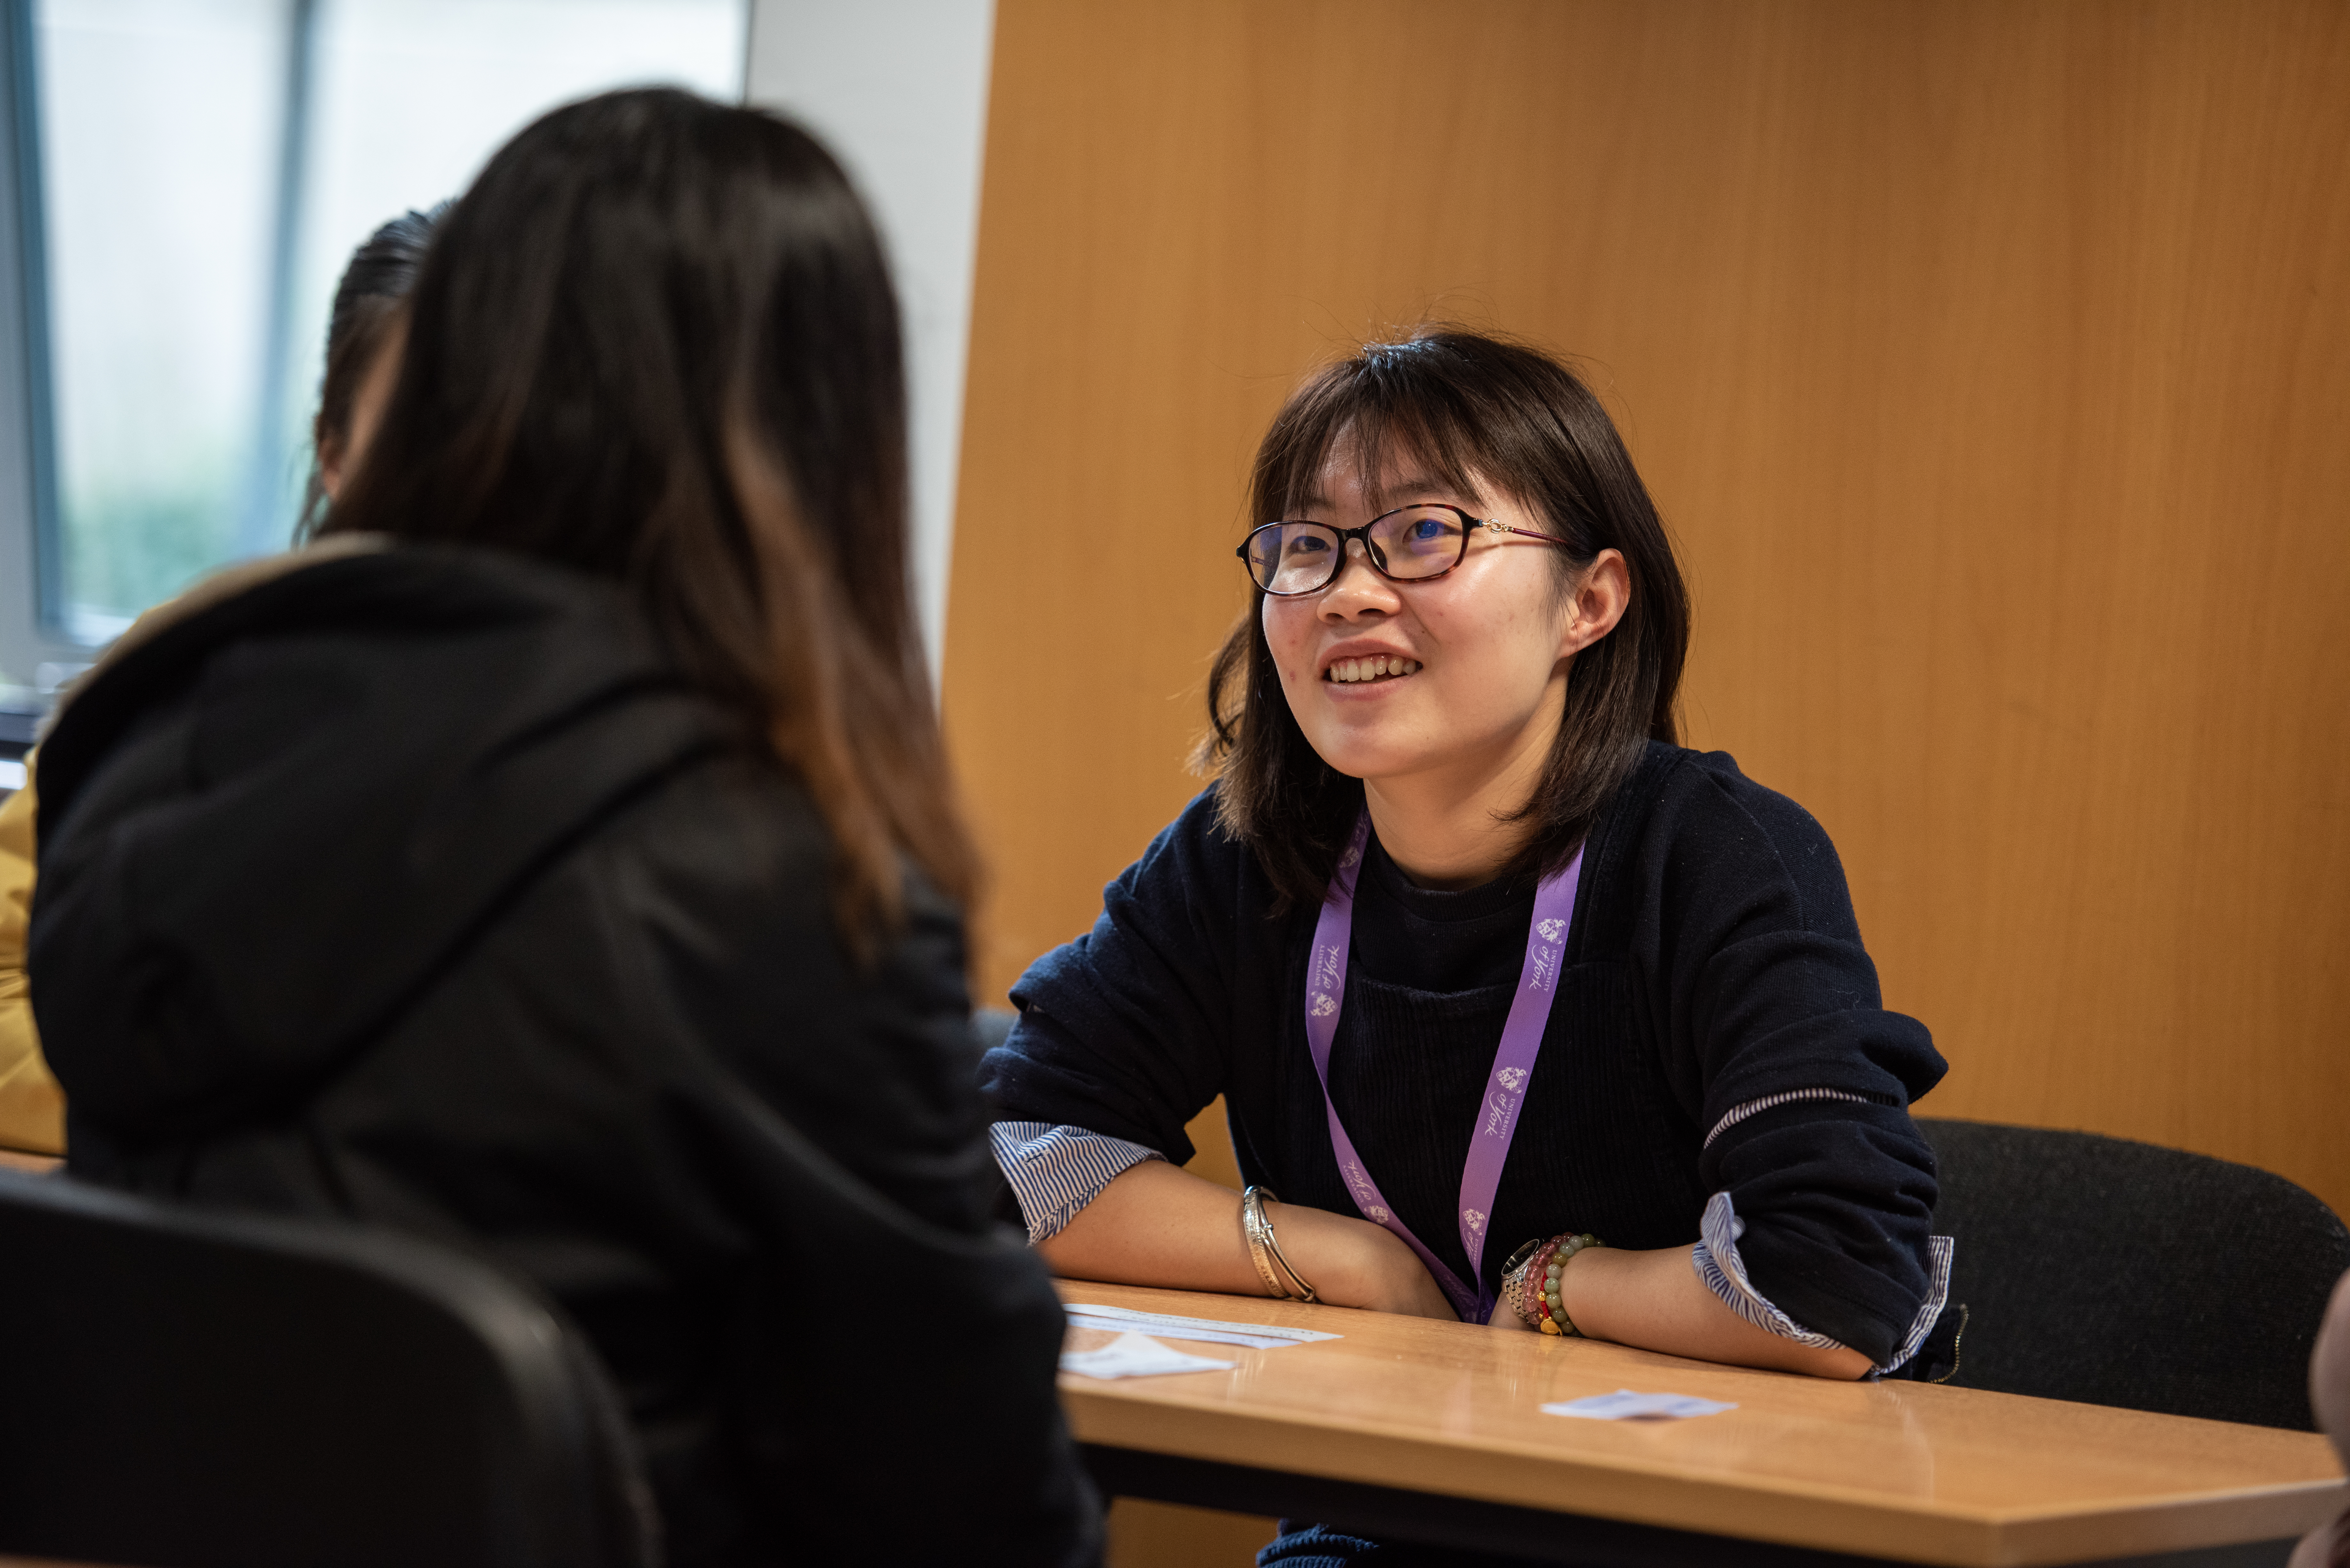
[{"x1": 1060, "y1": 1281, "x2": 2345, "y2": 1568}]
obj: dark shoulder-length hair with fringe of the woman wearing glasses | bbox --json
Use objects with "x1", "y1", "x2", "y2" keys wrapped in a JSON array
[{"x1": 1199, "y1": 327, "x2": 1690, "y2": 908}]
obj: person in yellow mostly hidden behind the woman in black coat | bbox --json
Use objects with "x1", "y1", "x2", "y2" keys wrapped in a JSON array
[{"x1": 0, "y1": 202, "x2": 446, "y2": 1154}]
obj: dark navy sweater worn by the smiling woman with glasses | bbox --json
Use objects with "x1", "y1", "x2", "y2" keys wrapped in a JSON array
[{"x1": 982, "y1": 743, "x2": 1944, "y2": 1363}]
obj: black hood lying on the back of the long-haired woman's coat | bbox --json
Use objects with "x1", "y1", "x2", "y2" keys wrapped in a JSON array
[{"x1": 28, "y1": 546, "x2": 745, "y2": 1142}]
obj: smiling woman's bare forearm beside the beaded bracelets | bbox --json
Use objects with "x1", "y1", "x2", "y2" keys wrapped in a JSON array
[{"x1": 1542, "y1": 1246, "x2": 1871, "y2": 1380}]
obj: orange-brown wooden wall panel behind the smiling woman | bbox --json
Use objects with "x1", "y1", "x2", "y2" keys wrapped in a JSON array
[{"x1": 945, "y1": 0, "x2": 2350, "y2": 1241}]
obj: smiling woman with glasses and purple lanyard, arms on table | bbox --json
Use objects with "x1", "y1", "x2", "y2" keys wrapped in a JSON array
[{"x1": 985, "y1": 331, "x2": 1955, "y2": 1563}]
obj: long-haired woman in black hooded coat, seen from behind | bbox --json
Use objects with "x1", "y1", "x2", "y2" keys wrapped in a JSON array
[{"x1": 33, "y1": 92, "x2": 1097, "y2": 1566}]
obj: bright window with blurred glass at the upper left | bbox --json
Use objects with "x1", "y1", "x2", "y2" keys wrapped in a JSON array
[{"x1": 0, "y1": 0, "x2": 747, "y2": 705}]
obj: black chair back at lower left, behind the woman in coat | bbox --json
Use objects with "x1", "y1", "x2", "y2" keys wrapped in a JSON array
[{"x1": 0, "y1": 1173, "x2": 660, "y2": 1568}]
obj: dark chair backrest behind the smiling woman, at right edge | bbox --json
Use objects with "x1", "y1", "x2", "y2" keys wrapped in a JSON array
[{"x1": 1918, "y1": 1119, "x2": 2350, "y2": 1429}]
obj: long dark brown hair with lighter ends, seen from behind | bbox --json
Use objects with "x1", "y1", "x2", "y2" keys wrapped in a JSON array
[{"x1": 322, "y1": 89, "x2": 975, "y2": 950}]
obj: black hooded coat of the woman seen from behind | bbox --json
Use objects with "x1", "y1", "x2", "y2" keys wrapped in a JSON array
[{"x1": 31, "y1": 548, "x2": 1097, "y2": 1566}]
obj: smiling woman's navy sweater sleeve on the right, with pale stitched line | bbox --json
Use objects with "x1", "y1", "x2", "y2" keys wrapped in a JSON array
[{"x1": 1636, "y1": 757, "x2": 1946, "y2": 1368}]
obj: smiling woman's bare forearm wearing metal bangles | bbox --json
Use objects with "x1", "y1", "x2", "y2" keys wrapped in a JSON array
[{"x1": 1036, "y1": 1159, "x2": 1452, "y2": 1316}]
